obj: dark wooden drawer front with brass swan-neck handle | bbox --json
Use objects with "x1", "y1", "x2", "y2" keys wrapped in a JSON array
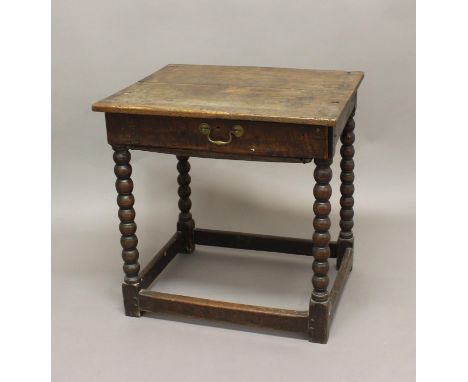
[{"x1": 106, "y1": 113, "x2": 330, "y2": 160}]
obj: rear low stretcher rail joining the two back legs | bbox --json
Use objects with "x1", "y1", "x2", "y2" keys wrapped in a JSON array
[{"x1": 195, "y1": 228, "x2": 336, "y2": 257}]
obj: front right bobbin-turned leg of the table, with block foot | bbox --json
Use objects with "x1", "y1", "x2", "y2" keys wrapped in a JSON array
[{"x1": 309, "y1": 159, "x2": 332, "y2": 343}]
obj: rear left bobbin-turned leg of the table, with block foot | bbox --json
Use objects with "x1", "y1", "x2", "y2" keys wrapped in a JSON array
[{"x1": 177, "y1": 156, "x2": 195, "y2": 253}]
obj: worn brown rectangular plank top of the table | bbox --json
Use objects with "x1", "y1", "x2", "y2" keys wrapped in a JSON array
[{"x1": 92, "y1": 64, "x2": 364, "y2": 126}]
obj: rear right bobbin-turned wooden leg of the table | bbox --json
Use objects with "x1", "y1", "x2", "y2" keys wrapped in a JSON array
[{"x1": 336, "y1": 112, "x2": 354, "y2": 269}]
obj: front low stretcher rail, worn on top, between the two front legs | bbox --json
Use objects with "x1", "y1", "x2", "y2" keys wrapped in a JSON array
[{"x1": 139, "y1": 290, "x2": 308, "y2": 333}]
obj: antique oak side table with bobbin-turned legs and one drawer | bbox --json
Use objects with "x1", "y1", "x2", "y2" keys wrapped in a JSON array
[{"x1": 92, "y1": 65, "x2": 364, "y2": 343}]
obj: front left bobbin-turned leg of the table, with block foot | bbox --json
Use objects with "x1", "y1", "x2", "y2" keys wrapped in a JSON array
[{"x1": 114, "y1": 147, "x2": 141, "y2": 317}]
